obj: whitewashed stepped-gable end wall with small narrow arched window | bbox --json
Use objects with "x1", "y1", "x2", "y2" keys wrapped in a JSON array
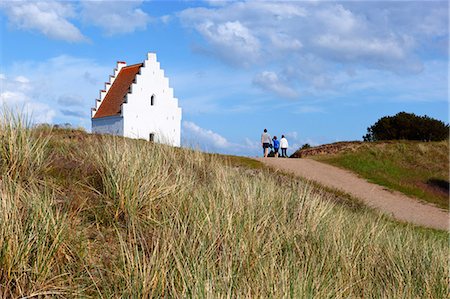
[{"x1": 122, "y1": 53, "x2": 181, "y2": 146}]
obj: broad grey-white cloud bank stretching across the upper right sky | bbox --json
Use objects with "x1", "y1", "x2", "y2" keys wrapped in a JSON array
[{"x1": 179, "y1": 1, "x2": 448, "y2": 68}]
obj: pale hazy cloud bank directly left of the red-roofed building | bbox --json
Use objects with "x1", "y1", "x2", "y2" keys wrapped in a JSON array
[{"x1": 0, "y1": 55, "x2": 112, "y2": 128}]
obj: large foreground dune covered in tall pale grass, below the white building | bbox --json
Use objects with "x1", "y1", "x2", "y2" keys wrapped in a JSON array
[{"x1": 0, "y1": 115, "x2": 448, "y2": 298}]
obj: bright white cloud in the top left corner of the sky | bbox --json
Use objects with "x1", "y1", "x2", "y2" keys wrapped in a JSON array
[{"x1": 0, "y1": 1, "x2": 86, "y2": 42}]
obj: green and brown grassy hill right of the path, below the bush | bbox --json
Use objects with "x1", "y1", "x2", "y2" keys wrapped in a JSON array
[{"x1": 297, "y1": 141, "x2": 449, "y2": 210}]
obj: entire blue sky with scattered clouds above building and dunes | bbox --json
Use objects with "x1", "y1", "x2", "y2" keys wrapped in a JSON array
[{"x1": 0, "y1": 1, "x2": 449, "y2": 156}]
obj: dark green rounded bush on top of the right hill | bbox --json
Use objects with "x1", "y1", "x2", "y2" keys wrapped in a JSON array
[{"x1": 363, "y1": 112, "x2": 449, "y2": 141}]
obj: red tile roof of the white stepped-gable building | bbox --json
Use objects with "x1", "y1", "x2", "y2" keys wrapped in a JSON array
[{"x1": 93, "y1": 63, "x2": 143, "y2": 118}]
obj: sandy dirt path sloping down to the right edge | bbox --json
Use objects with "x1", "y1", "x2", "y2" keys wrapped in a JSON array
[{"x1": 257, "y1": 158, "x2": 449, "y2": 230}]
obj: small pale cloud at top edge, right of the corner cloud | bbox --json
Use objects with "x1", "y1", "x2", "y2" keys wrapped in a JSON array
[{"x1": 81, "y1": 0, "x2": 150, "y2": 35}]
